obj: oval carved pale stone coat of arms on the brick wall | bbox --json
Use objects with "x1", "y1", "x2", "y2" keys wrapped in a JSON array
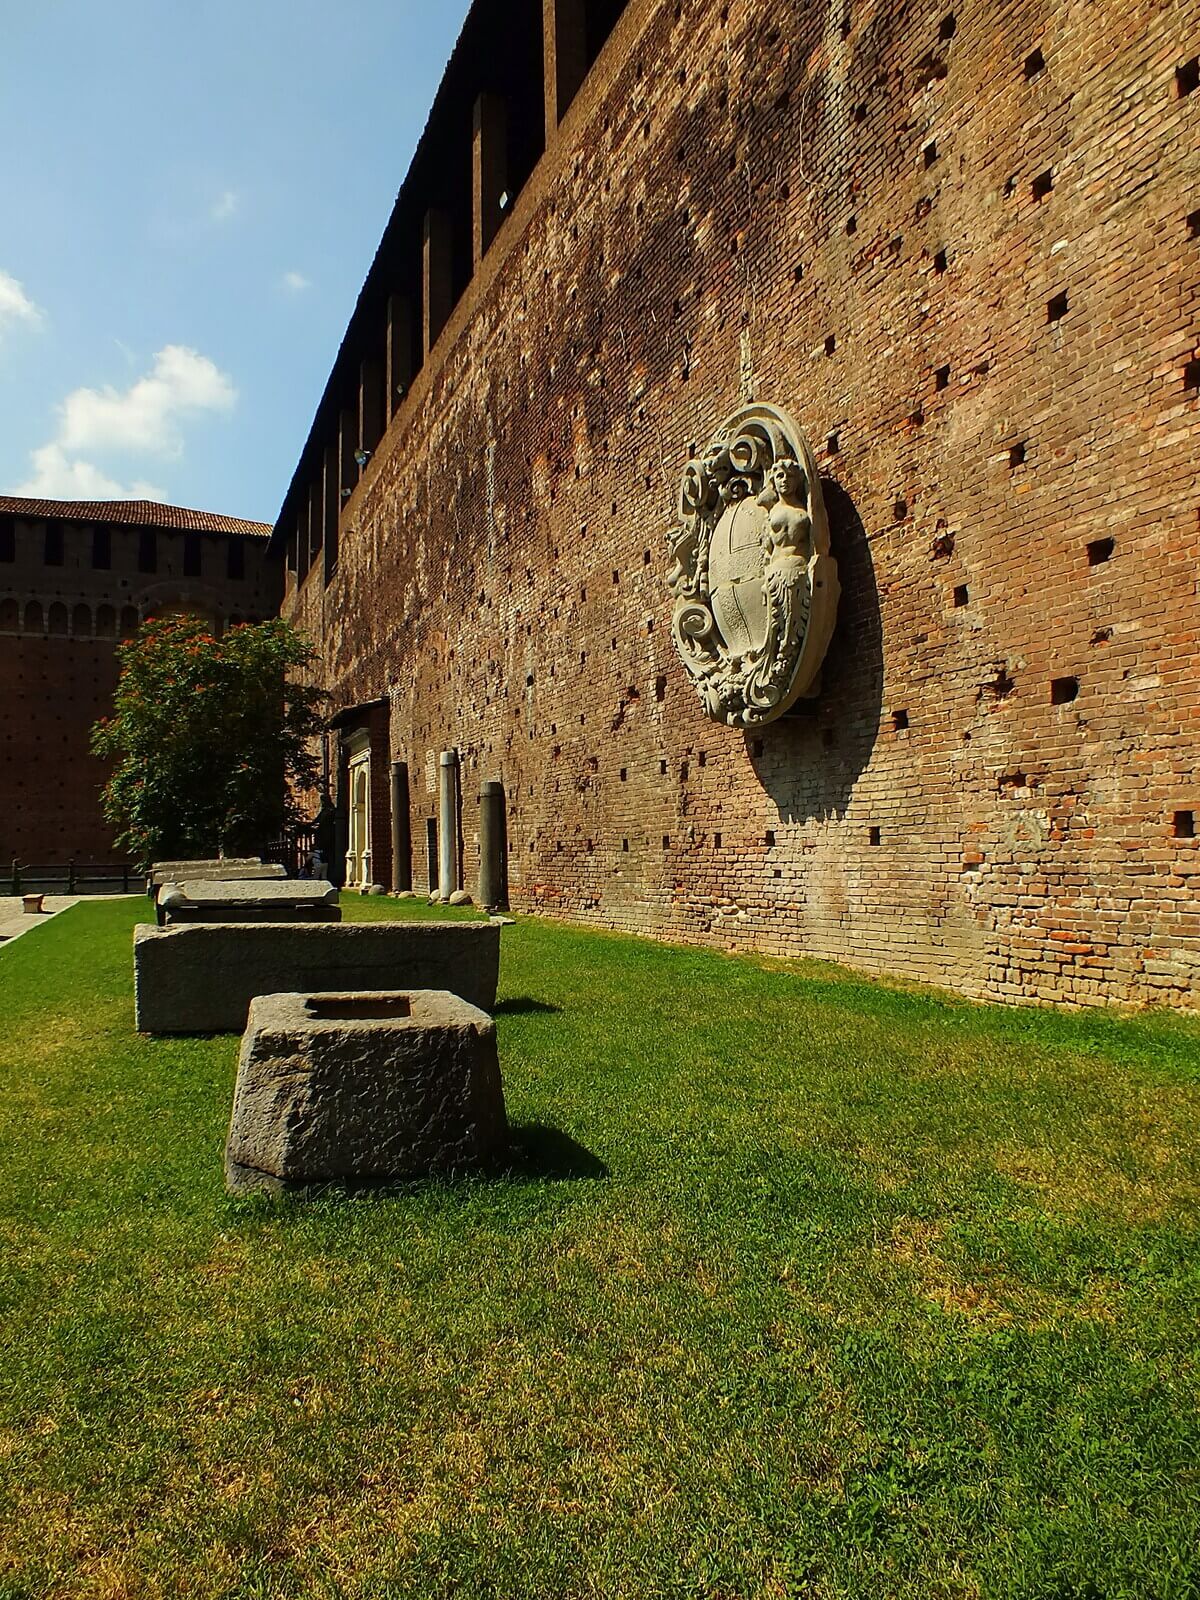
[{"x1": 667, "y1": 405, "x2": 840, "y2": 728}]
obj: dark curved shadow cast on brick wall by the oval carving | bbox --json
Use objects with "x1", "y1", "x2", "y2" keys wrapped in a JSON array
[{"x1": 746, "y1": 478, "x2": 883, "y2": 822}]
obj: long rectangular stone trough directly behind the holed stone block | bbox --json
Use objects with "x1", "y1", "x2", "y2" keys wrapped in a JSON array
[{"x1": 133, "y1": 922, "x2": 501, "y2": 1034}]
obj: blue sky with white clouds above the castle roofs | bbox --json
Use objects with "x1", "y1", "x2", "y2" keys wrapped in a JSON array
[{"x1": 0, "y1": 0, "x2": 467, "y2": 522}]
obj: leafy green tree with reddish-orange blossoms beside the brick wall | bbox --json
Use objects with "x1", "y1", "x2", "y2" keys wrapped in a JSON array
[{"x1": 91, "y1": 616, "x2": 323, "y2": 864}]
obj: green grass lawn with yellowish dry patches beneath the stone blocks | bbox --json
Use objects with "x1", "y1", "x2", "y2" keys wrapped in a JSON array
[{"x1": 0, "y1": 901, "x2": 1200, "y2": 1600}]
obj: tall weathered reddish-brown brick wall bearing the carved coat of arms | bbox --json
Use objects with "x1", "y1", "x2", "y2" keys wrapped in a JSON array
[{"x1": 288, "y1": 0, "x2": 1200, "y2": 1003}]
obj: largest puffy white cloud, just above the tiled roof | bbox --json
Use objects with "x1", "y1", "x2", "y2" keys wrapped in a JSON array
[{"x1": 14, "y1": 344, "x2": 237, "y2": 499}]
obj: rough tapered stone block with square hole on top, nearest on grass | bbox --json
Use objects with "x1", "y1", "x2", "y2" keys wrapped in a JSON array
[{"x1": 226, "y1": 989, "x2": 507, "y2": 1192}]
